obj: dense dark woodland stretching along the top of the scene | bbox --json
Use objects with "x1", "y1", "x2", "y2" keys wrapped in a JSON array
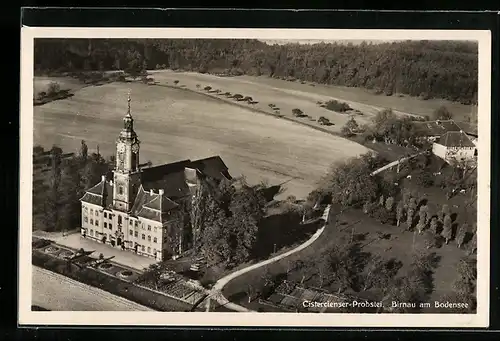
[{"x1": 35, "y1": 39, "x2": 478, "y2": 104}]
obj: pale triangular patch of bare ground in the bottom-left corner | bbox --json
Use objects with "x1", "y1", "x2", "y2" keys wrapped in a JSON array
[{"x1": 31, "y1": 266, "x2": 153, "y2": 311}]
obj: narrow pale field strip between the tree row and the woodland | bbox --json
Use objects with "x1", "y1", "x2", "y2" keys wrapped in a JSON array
[{"x1": 151, "y1": 70, "x2": 477, "y2": 127}]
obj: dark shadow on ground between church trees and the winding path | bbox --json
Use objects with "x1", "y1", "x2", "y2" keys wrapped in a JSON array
[{"x1": 252, "y1": 213, "x2": 321, "y2": 260}]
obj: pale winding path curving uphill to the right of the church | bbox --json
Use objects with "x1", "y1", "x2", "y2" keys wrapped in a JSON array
[{"x1": 210, "y1": 205, "x2": 331, "y2": 312}]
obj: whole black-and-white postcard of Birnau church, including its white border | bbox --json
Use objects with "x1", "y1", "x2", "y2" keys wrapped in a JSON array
[{"x1": 19, "y1": 28, "x2": 491, "y2": 327}]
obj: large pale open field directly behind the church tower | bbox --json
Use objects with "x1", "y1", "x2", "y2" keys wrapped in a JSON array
[{"x1": 34, "y1": 78, "x2": 368, "y2": 197}]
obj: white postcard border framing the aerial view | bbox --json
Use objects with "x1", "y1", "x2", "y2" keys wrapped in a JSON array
[{"x1": 18, "y1": 26, "x2": 491, "y2": 328}]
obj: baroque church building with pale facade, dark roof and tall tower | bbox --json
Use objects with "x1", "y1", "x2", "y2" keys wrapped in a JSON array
[{"x1": 80, "y1": 96, "x2": 231, "y2": 261}]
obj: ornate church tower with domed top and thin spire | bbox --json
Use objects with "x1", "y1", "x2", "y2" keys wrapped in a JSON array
[{"x1": 113, "y1": 93, "x2": 140, "y2": 212}]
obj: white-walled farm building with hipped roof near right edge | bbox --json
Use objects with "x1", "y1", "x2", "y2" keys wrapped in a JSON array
[{"x1": 432, "y1": 131, "x2": 477, "y2": 164}]
